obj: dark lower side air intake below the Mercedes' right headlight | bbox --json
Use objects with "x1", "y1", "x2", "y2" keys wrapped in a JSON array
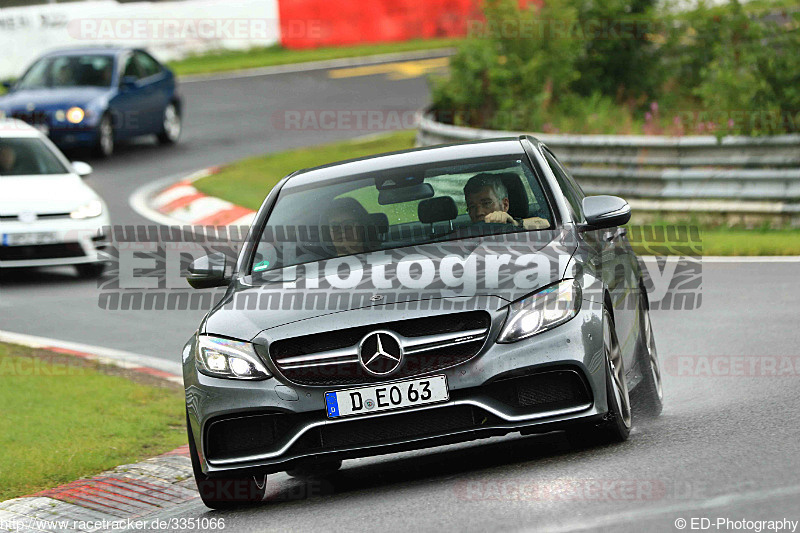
[{"x1": 485, "y1": 370, "x2": 590, "y2": 413}]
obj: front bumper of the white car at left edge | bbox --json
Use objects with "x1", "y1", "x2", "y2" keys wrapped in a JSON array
[{"x1": 0, "y1": 214, "x2": 110, "y2": 268}]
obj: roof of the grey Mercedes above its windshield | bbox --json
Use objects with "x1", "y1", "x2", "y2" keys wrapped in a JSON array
[{"x1": 287, "y1": 137, "x2": 525, "y2": 187}]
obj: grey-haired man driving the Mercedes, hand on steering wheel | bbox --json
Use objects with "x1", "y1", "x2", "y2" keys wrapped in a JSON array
[{"x1": 464, "y1": 173, "x2": 550, "y2": 229}]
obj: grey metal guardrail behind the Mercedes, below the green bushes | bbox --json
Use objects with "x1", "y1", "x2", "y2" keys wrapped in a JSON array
[{"x1": 417, "y1": 114, "x2": 800, "y2": 225}]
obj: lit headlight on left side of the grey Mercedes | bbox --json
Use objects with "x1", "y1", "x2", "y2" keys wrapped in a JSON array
[{"x1": 195, "y1": 335, "x2": 271, "y2": 379}]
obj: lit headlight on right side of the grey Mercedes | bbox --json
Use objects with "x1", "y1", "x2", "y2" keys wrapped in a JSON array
[{"x1": 497, "y1": 279, "x2": 581, "y2": 342}]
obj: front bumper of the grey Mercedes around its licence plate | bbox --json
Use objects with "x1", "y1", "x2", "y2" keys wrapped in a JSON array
[{"x1": 184, "y1": 305, "x2": 608, "y2": 476}]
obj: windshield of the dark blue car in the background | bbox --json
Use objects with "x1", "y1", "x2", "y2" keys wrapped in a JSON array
[{"x1": 16, "y1": 55, "x2": 114, "y2": 89}]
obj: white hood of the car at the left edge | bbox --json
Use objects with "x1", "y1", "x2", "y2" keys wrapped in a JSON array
[{"x1": 0, "y1": 174, "x2": 98, "y2": 215}]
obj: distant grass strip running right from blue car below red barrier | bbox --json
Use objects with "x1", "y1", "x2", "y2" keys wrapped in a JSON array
[{"x1": 169, "y1": 39, "x2": 462, "y2": 76}]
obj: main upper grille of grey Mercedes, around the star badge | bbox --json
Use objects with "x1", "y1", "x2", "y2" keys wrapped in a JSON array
[{"x1": 269, "y1": 311, "x2": 491, "y2": 386}]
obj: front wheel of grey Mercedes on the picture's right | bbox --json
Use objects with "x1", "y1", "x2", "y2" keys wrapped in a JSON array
[{"x1": 567, "y1": 309, "x2": 632, "y2": 447}]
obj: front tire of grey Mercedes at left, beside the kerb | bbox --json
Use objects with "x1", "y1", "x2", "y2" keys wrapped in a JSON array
[{"x1": 186, "y1": 413, "x2": 267, "y2": 510}]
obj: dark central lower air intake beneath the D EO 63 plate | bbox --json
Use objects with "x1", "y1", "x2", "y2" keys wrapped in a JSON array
[{"x1": 321, "y1": 406, "x2": 477, "y2": 448}]
